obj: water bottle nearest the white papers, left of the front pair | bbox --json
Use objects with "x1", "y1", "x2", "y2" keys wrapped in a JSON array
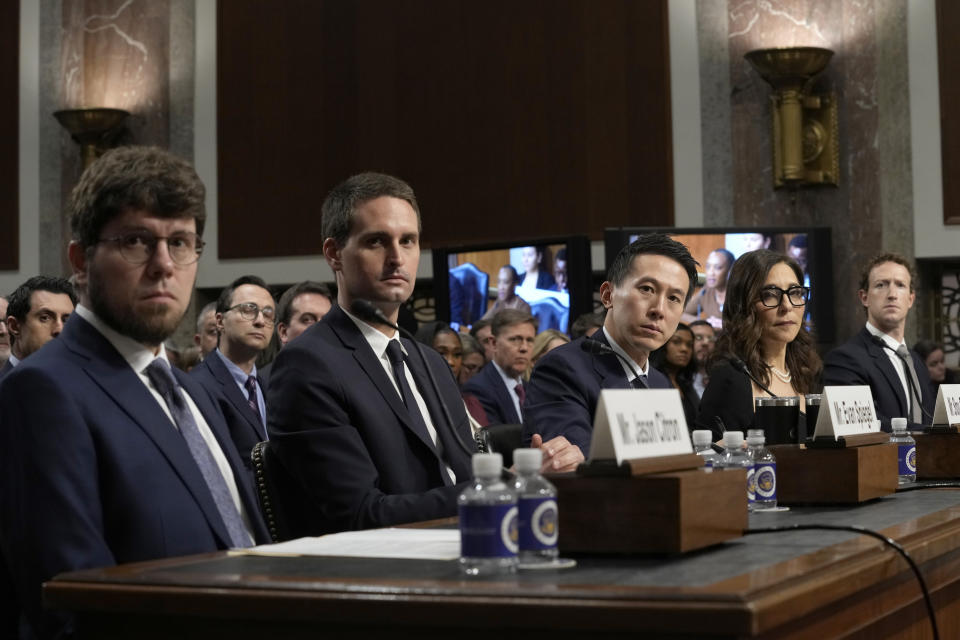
[{"x1": 457, "y1": 453, "x2": 518, "y2": 576}]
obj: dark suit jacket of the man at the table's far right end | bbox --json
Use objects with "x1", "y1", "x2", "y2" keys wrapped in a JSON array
[{"x1": 823, "y1": 327, "x2": 937, "y2": 431}]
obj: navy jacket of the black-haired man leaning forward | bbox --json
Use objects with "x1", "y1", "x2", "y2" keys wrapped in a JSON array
[{"x1": 523, "y1": 330, "x2": 673, "y2": 457}]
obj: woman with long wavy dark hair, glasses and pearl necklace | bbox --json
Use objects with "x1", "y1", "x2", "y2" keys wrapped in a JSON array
[{"x1": 697, "y1": 249, "x2": 823, "y2": 436}]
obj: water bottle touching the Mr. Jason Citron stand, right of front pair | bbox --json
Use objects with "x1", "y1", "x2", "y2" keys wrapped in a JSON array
[{"x1": 513, "y1": 449, "x2": 560, "y2": 565}]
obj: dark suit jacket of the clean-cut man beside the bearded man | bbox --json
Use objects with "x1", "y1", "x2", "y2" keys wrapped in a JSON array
[{"x1": 267, "y1": 307, "x2": 475, "y2": 534}]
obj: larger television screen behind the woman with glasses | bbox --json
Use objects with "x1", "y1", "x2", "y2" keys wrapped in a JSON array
[{"x1": 604, "y1": 227, "x2": 834, "y2": 343}]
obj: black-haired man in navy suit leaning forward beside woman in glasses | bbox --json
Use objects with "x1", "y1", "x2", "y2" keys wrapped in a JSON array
[{"x1": 524, "y1": 234, "x2": 697, "y2": 456}]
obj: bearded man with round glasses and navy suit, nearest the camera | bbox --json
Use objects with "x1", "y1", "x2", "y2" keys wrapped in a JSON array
[{"x1": 0, "y1": 147, "x2": 267, "y2": 638}]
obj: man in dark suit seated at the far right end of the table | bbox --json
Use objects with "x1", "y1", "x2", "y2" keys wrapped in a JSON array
[{"x1": 823, "y1": 253, "x2": 936, "y2": 431}]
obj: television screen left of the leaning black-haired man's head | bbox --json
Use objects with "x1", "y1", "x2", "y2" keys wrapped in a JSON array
[{"x1": 432, "y1": 236, "x2": 593, "y2": 333}]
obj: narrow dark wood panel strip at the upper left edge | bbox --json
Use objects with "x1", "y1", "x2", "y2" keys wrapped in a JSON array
[{"x1": 0, "y1": 2, "x2": 20, "y2": 270}]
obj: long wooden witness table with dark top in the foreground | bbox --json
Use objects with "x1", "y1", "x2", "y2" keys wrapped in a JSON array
[{"x1": 44, "y1": 489, "x2": 960, "y2": 640}]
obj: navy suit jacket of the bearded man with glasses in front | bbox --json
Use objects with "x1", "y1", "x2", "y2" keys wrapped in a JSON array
[{"x1": 0, "y1": 314, "x2": 268, "y2": 637}]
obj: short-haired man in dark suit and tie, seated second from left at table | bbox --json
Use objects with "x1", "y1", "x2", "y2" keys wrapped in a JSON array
[{"x1": 267, "y1": 173, "x2": 578, "y2": 533}]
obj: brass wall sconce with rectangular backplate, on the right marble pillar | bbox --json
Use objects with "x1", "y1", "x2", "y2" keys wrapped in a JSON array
[{"x1": 744, "y1": 47, "x2": 840, "y2": 189}]
